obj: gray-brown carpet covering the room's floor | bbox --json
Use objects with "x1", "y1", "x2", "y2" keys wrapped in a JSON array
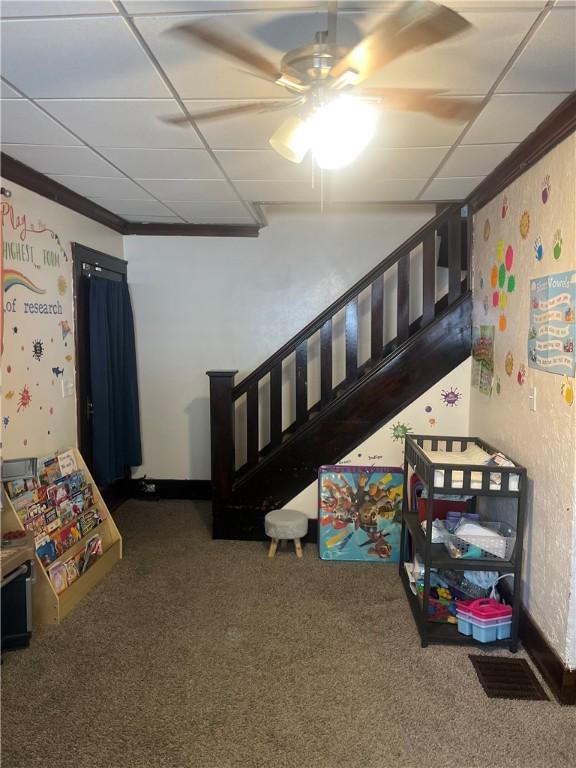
[{"x1": 2, "y1": 501, "x2": 576, "y2": 768}]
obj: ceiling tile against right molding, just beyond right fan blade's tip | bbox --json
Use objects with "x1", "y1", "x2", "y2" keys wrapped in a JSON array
[{"x1": 462, "y1": 93, "x2": 570, "y2": 144}]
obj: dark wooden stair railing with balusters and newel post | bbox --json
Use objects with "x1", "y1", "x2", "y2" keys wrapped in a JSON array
[{"x1": 207, "y1": 203, "x2": 471, "y2": 524}]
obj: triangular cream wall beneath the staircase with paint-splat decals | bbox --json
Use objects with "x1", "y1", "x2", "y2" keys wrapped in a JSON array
[{"x1": 285, "y1": 358, "x2": 470, "y2": 518}]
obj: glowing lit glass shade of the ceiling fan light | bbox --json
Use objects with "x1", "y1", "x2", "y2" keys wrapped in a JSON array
[{"x1": 308, "y1": 96, "x2": 378, "y2": 170}]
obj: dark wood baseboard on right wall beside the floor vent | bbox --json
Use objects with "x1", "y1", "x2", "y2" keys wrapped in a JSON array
[{"x1": 520, "y1": 608, "x2": 576, "y2": 705}]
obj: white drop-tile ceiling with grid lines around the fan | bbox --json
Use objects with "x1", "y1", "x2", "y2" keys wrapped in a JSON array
[{"x1": 0, "y1": 0, "x2": 576, "y2": 224}]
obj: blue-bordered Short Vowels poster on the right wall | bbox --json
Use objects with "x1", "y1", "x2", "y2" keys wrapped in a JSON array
[{"x1": 528, "y1": 270, "x2": 576, "y2": 376}]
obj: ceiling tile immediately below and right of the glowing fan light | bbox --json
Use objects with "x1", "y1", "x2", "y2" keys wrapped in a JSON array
[{"x1": 327, "y1": 147, "x2": 450, "y2": 183}]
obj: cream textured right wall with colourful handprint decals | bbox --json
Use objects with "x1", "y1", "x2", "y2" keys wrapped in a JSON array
[{"x1": 470, "y1": 135, "x2": 576, "y2": 667}]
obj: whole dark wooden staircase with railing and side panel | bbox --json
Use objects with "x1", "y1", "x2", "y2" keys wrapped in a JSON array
[{"x1": 207, "y1": 204, "x2": 472, "y2": 539}]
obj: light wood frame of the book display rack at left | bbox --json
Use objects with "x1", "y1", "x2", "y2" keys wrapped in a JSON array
[{"x1": 2, "y1": 448, "x2": 122, "y2": 626}]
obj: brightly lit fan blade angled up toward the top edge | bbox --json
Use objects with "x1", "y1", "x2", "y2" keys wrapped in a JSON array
[{"x1": 330, "y1": 0, "x2": 472, "y2": 83}]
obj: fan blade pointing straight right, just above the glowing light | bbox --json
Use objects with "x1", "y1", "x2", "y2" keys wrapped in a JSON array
[{"x1": 361, "y1": 88, "x2": 482, "y2": 122}]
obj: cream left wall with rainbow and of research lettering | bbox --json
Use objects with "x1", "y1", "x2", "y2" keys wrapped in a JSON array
[{"x1": 0, "y1": 181, "x2": 123, "y2": 458}]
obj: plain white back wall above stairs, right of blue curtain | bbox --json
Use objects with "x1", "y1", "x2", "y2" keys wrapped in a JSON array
[{"x1": 125, "y1": 206, "x2": 434, "y2": 479}]
